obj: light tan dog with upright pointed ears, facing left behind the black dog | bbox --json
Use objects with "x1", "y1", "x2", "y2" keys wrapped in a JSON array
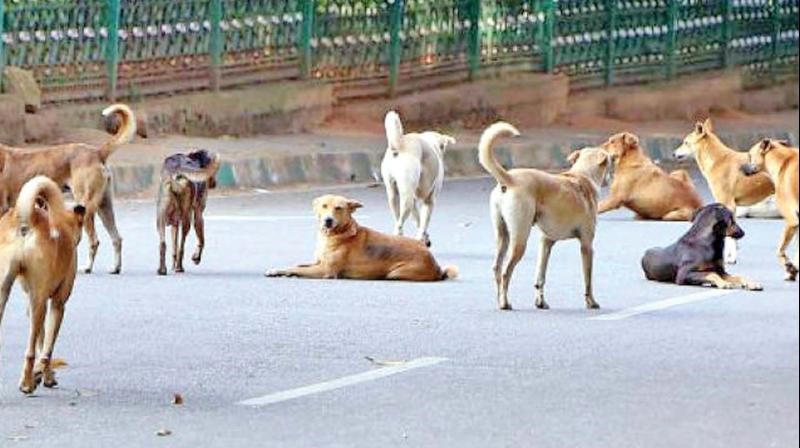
[{"x1": 674, "y1": 119, "x2": 775, "y2": 264}]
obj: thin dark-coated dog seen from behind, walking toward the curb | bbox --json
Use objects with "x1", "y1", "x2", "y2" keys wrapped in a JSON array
[{"x1": 156, "y1": 150, "x2": 220, "y2": 275}]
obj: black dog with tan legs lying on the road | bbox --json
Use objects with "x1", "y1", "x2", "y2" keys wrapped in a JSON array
[{"x1": 642, "y1": 204, "x2": 763, "y2": 291}]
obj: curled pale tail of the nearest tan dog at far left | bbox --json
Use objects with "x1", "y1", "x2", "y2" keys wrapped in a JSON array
[{"x1": 16, "y1": 176, "x2": 64, "y2": 236}]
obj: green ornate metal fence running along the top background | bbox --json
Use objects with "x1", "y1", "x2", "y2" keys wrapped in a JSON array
[{"x1": 0, "y1": 0, "x2": 800, "y2": 102}]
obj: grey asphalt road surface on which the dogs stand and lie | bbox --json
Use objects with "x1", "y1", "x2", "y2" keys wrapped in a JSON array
[{"x1": 0, "y1": 180, "x2": 799, "y2": 448}]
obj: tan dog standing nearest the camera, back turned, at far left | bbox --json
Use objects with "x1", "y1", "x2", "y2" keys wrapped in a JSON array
[{"x1": 0, "y1": 176, "x2": 86, "y2": 394}]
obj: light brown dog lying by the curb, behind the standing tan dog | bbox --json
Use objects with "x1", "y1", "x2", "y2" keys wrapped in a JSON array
[{"x1": 599, "y1": 133, "x2": 703, "y2": 221}]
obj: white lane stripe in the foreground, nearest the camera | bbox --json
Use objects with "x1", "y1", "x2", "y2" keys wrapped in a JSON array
[{"x1": 237, "y1": 358, "x2": 447, "y2": 407}]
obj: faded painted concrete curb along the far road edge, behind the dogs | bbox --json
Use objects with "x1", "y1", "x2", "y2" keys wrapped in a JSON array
[{"x1": 113, "y1": 130, "x2": 797, "y2": 196}]
